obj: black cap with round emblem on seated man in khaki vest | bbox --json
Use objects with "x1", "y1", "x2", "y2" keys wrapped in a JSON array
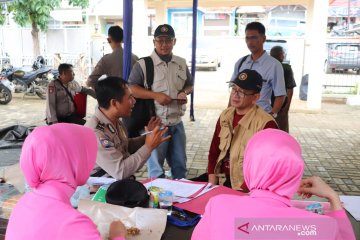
[{"x1": 229, "y1": 69, "x2": 263, "y2": 92}]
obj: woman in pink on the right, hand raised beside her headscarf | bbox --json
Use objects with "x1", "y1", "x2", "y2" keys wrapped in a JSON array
[{"x1": 192, "y1": 129, "x2": 355, "y2": 240}]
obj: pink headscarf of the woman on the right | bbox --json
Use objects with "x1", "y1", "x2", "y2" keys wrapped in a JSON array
[{"x1": 243, "y1": 129, "x2": 304, "y2": 199}]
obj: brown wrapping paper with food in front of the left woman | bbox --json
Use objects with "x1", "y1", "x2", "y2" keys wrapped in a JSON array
[{"x1": 78, "y1": 199, "x2": 167, "y2": 240}]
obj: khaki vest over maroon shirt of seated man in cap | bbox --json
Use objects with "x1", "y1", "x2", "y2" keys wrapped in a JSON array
[{"x1": 215, "y1": 105, "x2": 274, "y2": 190}]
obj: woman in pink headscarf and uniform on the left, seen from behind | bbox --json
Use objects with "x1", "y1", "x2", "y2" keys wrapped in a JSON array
[{"x1": 5, "y1": 123, "x2": 126, "y2": 240}]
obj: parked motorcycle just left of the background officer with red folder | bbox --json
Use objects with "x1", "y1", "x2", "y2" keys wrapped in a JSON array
[{"x1": 3, "y1": 56, "x2": 51, "y2": 99}]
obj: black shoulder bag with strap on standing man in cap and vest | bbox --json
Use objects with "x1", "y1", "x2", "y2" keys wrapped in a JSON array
[{"x1": 122, "y1": 57, "x2": 156, "y2": 138}]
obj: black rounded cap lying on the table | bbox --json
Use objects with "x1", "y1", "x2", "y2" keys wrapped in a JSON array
[{"x1": 105, "y1": 179, "x2": 149, "y2": 208}]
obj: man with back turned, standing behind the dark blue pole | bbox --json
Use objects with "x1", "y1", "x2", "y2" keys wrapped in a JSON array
[{"x1": 86, "y1": 26, "x2": 138, "y2": 88}]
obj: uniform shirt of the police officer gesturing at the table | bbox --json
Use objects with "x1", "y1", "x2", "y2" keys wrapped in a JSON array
[{"x1": 85, "y1": 108, "x2": 151, "y2": 179}]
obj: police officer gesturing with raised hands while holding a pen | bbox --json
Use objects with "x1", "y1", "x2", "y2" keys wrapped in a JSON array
[{"x1": 85, "y1": 77, "x2": 170, "y2": 179}]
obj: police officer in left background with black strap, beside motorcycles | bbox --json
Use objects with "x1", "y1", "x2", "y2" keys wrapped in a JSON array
[{"x1": 46, "y1": 63, "x2": 96, "y2": 125}]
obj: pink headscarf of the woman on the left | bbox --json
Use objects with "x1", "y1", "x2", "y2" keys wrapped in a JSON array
[{"x1": 20, "y1": 123, "x2": 97, "y2": 198}]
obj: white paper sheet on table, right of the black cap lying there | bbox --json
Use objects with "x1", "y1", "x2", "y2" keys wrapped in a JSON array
[{"x1": 144, "y1": 178, "x2": 206, "y2": 197}]
